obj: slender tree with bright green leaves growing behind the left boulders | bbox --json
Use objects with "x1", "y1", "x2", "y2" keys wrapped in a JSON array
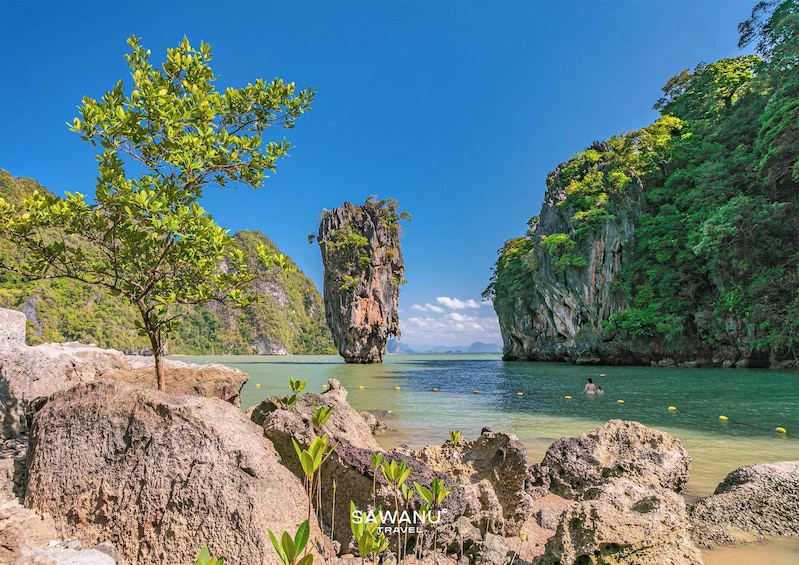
[{"x1": 0, "y1": 36, "x2": 315, "y2": 390}]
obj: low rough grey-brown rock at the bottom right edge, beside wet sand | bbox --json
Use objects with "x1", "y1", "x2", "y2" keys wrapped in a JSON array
[{"x1": 691, "y1": 461, "x2": 799, "y2": 547}]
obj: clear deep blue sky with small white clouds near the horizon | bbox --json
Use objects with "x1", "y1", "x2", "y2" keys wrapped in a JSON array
[{"x1": 0, "y1": 0, "x2": 755, "y2": 346}]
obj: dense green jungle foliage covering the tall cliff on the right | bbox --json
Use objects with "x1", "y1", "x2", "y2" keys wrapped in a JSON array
[{"x1": 486, "y1": 0, "x2": 799, "y2": 356}]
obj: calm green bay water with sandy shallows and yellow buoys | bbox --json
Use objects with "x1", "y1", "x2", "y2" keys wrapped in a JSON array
[{"x1": 175, "y1": 355, "x2": 799, "y2": 565}]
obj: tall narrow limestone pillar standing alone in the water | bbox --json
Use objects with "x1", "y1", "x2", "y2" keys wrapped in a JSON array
[{"x1": 317, "y1": 198, "x2": 405, "y2": 363}]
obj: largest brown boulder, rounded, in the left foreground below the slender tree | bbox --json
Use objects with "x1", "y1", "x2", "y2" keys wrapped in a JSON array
[{"x1": 25, "y1": 382, "x2": 319, "y2": 564}]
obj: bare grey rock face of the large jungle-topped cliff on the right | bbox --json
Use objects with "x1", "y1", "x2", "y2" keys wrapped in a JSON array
[{"x1": 494, "y1": 154, "x2": 643, "y2": 362}]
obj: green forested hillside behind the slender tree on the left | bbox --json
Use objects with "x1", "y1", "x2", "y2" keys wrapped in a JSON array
[{"x1": 0, "y1": 170, "x2": 336, "y2": 355}]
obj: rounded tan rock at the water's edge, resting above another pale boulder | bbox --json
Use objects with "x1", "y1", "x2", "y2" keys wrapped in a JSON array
[{"x1": 530, "y1": 420, "x2": 691, "y2": 500}]
